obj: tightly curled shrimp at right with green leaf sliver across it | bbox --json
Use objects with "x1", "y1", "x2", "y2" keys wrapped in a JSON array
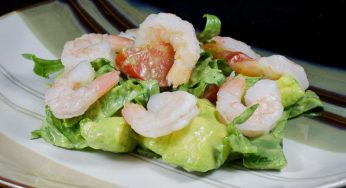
[{"x1": 216, "y1": 77, "x2": 283, "y2": 137}]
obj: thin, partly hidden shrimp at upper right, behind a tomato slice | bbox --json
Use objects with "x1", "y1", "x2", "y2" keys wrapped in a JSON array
[{"x1": 213, "y1": 36, "x2": 260, "y2": 59}]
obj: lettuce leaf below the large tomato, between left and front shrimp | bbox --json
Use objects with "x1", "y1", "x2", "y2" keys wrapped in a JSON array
[{"x1": 100, "y1": 79, "x2": 160, "y2": 117}]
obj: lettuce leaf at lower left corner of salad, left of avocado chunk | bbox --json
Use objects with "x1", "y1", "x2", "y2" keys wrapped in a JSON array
[{"x1": 31, "y1": 107, "x2": 87, "y2": 149}]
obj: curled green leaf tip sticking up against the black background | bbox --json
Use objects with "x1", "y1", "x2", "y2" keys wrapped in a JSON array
[{"x1": 198, "y1": 14, "x2": 221, "y2": 42}]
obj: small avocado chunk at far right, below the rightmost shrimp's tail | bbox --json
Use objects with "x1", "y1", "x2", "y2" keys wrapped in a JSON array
[{"x1": 276, "y1": 75, "x2": 304, "y2": 108}]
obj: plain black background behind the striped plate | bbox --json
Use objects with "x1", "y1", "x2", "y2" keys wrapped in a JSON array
[{"x1": 0, "y1": 0, "x2": 346, "y2": 69}]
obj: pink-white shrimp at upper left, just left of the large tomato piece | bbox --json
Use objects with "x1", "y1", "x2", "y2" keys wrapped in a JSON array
[{"x1": 61, "y1": 33, "x2": 134, "y2": 72}]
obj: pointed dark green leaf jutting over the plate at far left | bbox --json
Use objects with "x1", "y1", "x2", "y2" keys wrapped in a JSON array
[{"x1": 22, "y1": 54, "x2": 64, "y2": 78}]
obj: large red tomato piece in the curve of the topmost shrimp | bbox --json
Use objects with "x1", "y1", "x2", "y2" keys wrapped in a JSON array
[{"x1": 115, "y1": 43, "x2": 174, "y2": 87}]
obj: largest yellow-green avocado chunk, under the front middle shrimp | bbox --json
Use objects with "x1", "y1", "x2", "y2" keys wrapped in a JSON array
[{"x1": 139, "y1": 99, "x2": 230, "y2": 172}]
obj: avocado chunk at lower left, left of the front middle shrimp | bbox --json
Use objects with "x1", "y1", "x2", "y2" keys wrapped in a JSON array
[{"x1": 80, "y1": 117, "x2": 137, "y2": 153}]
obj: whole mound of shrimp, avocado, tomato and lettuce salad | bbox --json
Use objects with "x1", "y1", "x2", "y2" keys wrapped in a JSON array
[{"x1": 23, "y1": 13, "x2": 323, "y2": 172}]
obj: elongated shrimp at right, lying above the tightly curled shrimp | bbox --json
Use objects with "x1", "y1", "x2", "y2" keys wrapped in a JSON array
[{"x1": 230, "y1": 55, "x2": 309, "y2": 90}]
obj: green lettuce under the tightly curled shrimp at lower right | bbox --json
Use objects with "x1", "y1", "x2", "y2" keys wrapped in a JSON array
[{"x1": 227, "y1": 105, "x2": 289, "y2": 170}]
